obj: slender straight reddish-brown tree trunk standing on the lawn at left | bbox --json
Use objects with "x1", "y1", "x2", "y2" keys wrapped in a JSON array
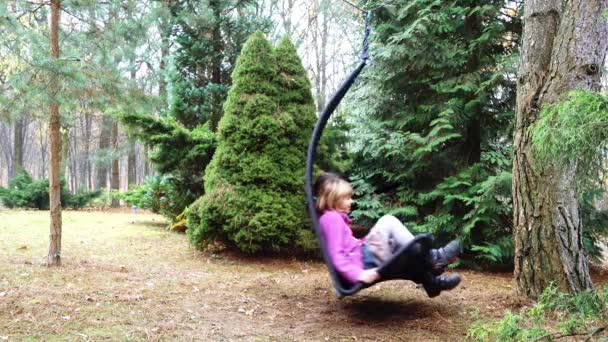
[{"x1": 47, "y1": 0, "x2": 61, "y2": 266}]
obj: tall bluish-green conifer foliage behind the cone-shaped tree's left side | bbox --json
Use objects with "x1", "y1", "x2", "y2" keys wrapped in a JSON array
[{"x1": 169, "y1": 0, "x2": 270, "y2": 130}]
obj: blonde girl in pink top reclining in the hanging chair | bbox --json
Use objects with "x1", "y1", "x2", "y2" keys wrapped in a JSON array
[{"x1": 315, "y1": 173, "x2": 461, "y2": 297}]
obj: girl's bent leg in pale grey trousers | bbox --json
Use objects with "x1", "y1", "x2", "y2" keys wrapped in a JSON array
[{"x1": 365, "y1": 215, "x2": 414, "y2": 265}]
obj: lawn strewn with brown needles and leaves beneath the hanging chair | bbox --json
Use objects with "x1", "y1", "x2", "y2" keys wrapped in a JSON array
[{"x1": 0, "y1": 210, "x2": 604, "y2": 341}]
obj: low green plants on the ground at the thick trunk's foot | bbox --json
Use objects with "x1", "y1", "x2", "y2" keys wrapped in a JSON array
[{"x1": 467, "y1": 284, "x2": 608, "y2": 341}]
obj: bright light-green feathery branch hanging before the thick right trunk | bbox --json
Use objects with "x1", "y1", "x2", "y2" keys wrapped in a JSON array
[{"x1": 530, "y1": 90, "x2": 608, "y2": 190}]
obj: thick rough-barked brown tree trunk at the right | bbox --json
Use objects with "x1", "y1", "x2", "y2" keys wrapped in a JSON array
[{"x1": 513, "y1": 0, "x2": 608, "y2": 298}]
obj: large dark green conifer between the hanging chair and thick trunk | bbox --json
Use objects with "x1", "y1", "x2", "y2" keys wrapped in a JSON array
[{"x1": 350, "y1": 0, "x2": 521, "y2": 265}]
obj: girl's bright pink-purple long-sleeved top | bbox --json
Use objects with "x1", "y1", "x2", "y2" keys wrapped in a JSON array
[{"x1": 319, "y1": 210, "x2": 363, "y2": 284}]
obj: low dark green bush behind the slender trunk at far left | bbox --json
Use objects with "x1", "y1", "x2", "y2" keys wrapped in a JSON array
[{"x1": 0, "y1": 170, "x2": 101, "y2": 210}]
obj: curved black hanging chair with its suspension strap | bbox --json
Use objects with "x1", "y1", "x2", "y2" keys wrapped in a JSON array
[{"x1": 305, "y1": 11, "x2": 432, "y2": 298}]
